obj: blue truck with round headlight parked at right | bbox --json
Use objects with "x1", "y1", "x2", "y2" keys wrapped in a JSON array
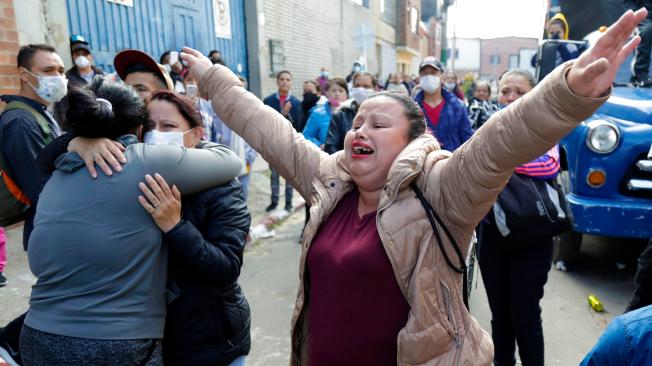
[{"x1": 537, "y1": 0, "x2": 652, "y2": 262}]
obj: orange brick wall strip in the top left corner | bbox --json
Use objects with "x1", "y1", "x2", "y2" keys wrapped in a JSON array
[{"x1": 0, "y1": 0, "x2": 20, "y2": 94}]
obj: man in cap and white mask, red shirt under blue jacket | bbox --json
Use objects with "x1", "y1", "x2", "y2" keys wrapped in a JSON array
[{"x1": 414, "y1": 56, "x2": 473, "y2": 151}]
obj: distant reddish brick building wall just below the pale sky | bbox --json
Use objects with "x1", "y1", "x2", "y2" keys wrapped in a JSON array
[{"x1": 480, "y1": 37, "x2": 538, "y2": 80}]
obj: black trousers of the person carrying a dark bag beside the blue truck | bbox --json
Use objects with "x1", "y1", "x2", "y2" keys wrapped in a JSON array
[{"x1": 478, "y1": 222, "x2": 552, "y2": 366}]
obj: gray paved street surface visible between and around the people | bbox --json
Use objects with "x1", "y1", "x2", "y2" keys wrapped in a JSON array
[{"x1": 0, "y1": 159, "x2": 642, "y2": 366}]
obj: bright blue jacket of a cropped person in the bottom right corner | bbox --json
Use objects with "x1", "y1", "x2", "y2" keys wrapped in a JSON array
[{"x1": 580, "y1": 305, "x2": 652, "y2": 366}]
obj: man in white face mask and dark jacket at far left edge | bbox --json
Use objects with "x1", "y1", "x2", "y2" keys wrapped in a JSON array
[{"x1": 0, "y1": 44, "x2": 68, "y2": 361}]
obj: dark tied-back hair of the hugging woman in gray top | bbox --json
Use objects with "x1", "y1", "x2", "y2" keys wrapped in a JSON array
[{"x1": 66, "y1": 76, "x2": 147, "y2": 139}]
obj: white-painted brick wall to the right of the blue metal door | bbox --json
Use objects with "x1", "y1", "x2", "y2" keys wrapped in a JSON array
[{"x1": 250, "y1": 0, "x2": 388, "y2": 97}]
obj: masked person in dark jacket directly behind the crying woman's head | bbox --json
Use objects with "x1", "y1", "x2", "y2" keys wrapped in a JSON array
[{"x1": 324, "y1": 72, "x2": 378, "y2": 154}]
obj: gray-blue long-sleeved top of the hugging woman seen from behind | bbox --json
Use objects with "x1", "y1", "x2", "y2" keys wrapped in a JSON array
[{"x1": 25, "y1": 135, "x2": 241, "y2": 339}]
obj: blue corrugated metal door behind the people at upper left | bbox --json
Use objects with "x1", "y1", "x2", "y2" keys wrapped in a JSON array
[{"x1": 66, "y1": 0, "x2": 247, "y2": 78}]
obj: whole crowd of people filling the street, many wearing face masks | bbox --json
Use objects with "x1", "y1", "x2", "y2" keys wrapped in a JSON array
[{"x1": 0, "y1": 10, "x2": 652, "y2": 366}]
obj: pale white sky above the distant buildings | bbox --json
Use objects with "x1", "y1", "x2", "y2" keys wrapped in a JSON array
[{"x1": 447, "y1": 0, "x2": 548, "y2": 38}]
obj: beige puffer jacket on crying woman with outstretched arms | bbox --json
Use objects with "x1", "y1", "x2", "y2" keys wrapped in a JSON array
[{"x1": 199, "y1": 64, "x2": 606, "y2": 366}]
